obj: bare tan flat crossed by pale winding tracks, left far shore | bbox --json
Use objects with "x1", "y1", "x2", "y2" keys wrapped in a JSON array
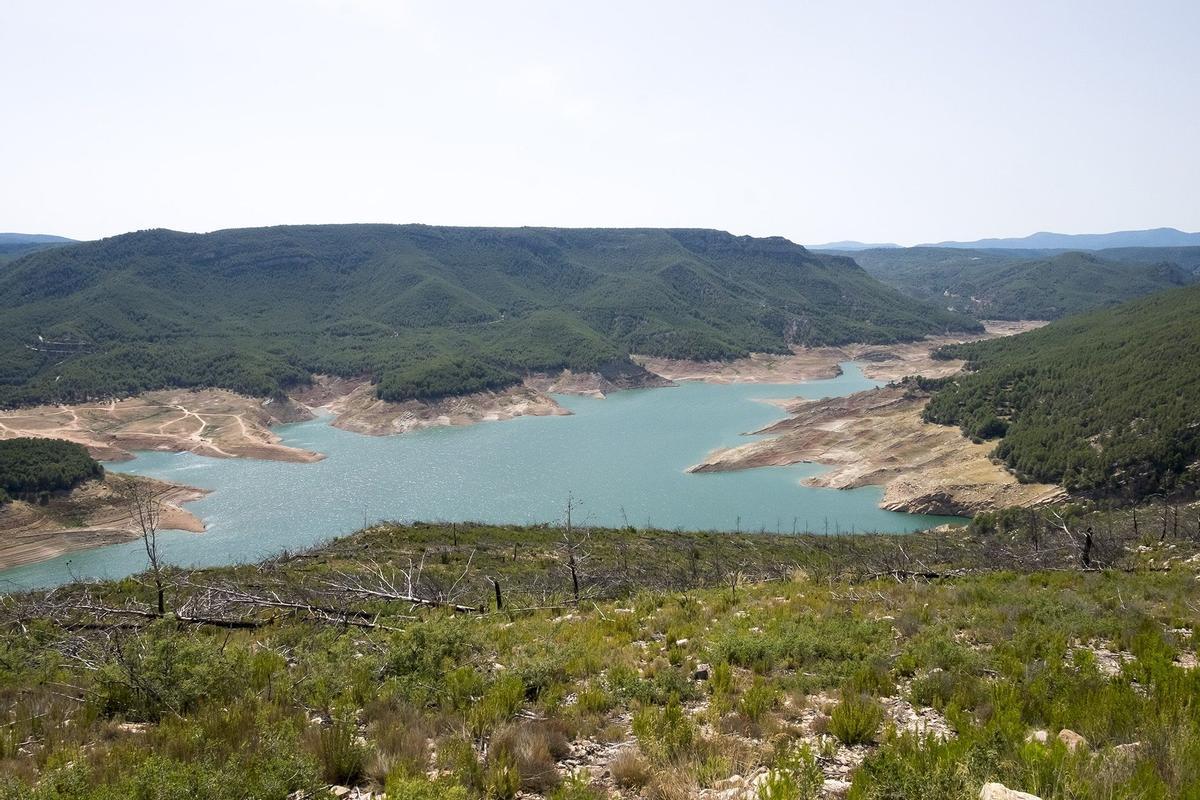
[{"x1": 0, "y1": 389, "x2": 323, "y2": 462}]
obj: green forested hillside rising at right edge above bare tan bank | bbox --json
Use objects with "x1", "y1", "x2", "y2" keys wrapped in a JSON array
[{"x1": 925, "y1": 287, "x2": 1200, "y2": 499}]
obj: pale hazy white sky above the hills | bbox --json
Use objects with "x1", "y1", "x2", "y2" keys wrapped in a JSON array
[{"x1": 0, "y1": 0, "x2": 1200, "y2": 243}]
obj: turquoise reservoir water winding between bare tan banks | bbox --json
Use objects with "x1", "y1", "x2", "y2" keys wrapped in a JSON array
[{"x1": 0, "y1": 363, "x2": 947, "y2": 590}]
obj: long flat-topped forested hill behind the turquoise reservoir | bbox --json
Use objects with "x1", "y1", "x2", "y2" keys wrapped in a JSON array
[{"x1": 0, "y1": 225, "x2": 978, "y2": 405}]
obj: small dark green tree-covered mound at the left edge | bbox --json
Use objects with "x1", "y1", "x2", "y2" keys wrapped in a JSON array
[{"x1": 0, "y1": 437, "x2": 104, "y2": 504}]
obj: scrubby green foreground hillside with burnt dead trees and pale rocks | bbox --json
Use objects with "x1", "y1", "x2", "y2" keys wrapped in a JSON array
[{"x1": 0, "y1": 505, "x2": 1200, "y2": 800}]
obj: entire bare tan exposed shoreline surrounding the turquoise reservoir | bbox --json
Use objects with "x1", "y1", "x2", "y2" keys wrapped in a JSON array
[{"x1": 0, "y1": 323, "x2": 1062, "y2": 570}]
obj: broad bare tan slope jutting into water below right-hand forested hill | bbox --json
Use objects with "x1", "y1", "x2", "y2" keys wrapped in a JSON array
[{"x1": 689, "y1": 386, "x2": 1064, "y2": 515}]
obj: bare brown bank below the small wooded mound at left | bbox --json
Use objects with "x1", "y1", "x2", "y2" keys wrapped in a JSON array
[{"x1": 0, "y1": 476, "x2": 206, "y2": 570}]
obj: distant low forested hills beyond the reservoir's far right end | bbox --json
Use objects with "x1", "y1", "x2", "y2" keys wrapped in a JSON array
[{"x1": 835, "y1": 247, "x2": 1200, "y2": 319}]
